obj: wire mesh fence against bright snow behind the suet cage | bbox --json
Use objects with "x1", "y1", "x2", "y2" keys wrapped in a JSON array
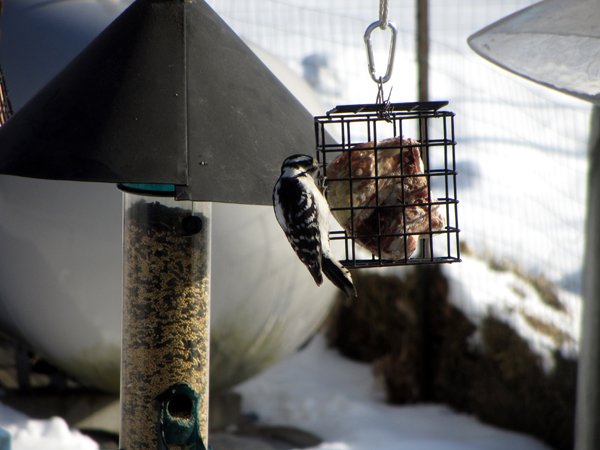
[{"x1": 210, "y1": 0, "x2": 590, "y2": 295}]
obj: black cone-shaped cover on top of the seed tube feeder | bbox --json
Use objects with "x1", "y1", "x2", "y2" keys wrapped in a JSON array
[{"x1": 0, "y1": 0, "x2": 314, "y2": 204}]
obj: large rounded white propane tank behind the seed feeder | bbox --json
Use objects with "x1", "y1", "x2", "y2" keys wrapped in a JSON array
[{"x1": 0, "y1": 0, "x2": 335, "y2": 393}]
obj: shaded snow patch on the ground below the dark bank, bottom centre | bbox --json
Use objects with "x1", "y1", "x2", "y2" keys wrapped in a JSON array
[{"x1": 238, "y1": 335, "x2": 548, "y2": 450}]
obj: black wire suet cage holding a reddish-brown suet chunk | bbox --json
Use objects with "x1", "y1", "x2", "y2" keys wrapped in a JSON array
[{"x1": 315, "y1": 101, "x2": 460, "y2": 268}]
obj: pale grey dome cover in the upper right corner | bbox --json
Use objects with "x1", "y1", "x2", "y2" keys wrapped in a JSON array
[{"x1": 468, "y1": 0, "x2": 600, "y2": 103}]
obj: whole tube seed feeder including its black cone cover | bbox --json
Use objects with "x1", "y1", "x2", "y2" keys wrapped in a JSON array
[{"x1": 0, "y1": 0, "x2": 314, "y2": 450}]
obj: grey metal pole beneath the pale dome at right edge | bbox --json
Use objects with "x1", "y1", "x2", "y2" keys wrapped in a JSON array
[{"x1": 575, "y1": 106, "x2": 600, "y2": 450}]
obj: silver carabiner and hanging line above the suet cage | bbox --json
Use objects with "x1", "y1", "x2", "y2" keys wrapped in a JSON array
[{"x1": 364, "y1": 0, "x2": 398, "y2": 120}]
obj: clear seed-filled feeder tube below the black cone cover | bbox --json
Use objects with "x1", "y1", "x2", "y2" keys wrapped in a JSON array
[{"x1": 119, "y1": 192, "x2": 211, "y2": 450}]
